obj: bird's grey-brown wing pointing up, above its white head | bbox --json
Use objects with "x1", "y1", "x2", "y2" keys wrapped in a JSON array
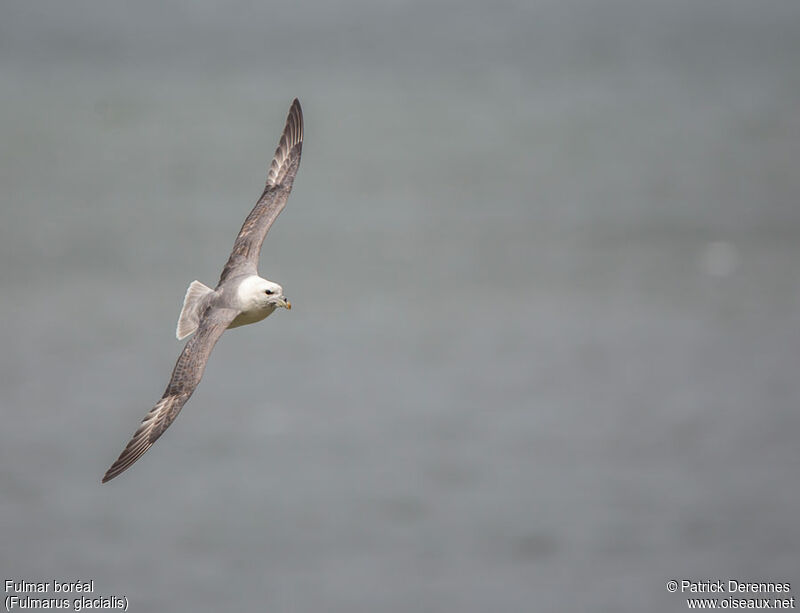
[{"x1": 219, "y1": 98, "x2": 303, "y2": 284}]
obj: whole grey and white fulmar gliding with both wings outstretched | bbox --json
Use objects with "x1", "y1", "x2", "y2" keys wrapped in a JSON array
[{"x1": 98, "y1": 98, "x2": 303, "y2": 483}]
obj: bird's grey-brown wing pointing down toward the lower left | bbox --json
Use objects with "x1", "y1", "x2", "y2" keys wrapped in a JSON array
[{"x1": 103, "y1": 307, "x2": 237, "y2": 483}]
